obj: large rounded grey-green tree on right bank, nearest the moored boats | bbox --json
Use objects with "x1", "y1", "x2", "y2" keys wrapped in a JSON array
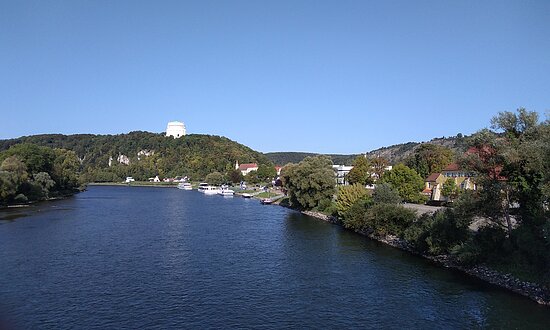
[{"x1": 281, "y1": 156, "x2": 336, "y2": 209}]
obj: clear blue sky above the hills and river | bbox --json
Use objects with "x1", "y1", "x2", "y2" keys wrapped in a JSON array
[{"x1": 0, "y1": 0, "x2": 550, "y2": 153}]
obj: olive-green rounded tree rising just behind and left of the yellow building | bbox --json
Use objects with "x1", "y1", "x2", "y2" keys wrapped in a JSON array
[{"x1": 405, "y1": 143, "x2": 454, "y2": 178}]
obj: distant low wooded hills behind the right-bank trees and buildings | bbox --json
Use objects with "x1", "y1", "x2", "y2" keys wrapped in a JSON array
[{"x1": 265, "y1": 134, "x2": 467, "y2": 165}]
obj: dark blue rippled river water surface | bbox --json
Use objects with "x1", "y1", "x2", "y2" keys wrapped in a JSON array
[{"x1": 0, "y1": 187, "x2": 550, "y2": 329}]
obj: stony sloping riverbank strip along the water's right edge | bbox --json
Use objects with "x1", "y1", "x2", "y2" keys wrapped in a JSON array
[{"x1": 300, "y1": 211, "x2": 550, "y2": 307}]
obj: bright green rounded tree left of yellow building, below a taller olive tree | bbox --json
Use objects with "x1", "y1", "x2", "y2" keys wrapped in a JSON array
[{"x1": 382, "y1": 164, "x2": 424, "y2": 203}]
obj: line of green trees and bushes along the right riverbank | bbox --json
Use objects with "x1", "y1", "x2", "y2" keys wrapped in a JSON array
[{"x1": 282, "y1": 108, "x2": 550, "y2": 285}]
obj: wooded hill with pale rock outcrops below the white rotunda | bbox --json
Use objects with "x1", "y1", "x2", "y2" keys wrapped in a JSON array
[{"x1": 0, "y1": 131, "x2": 271, "y2": 182}]
